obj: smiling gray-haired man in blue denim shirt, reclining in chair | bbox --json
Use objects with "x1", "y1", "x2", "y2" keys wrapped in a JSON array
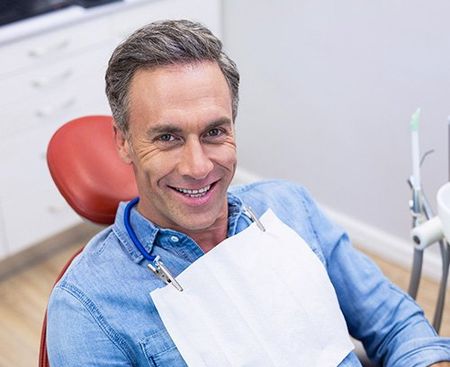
[{"x1": 47, "y1": 21, "x2": 450, "y2": 367}]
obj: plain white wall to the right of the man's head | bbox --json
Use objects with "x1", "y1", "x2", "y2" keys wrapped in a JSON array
[{"x1": 224, "y1": 0, "x2": 450, "y2": 278}]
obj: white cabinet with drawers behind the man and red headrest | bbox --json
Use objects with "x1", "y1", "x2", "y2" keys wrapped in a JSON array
[{"x1": 0, "y1": 0, "x2": 221, "y2": 259}]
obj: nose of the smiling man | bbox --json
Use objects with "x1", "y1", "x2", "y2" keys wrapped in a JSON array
[{"x1": 178, "y1": 139, "x2": 214, "y2": 180}]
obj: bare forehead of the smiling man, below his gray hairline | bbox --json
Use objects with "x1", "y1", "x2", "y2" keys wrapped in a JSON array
[{"x1": 129, "y1": 62, "x2": 231, "y2": 129}]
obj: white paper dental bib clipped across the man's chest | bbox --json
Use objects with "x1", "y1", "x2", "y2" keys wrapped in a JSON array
[{"x1": 150, "y1": 210, "x2": 353, "y2": 367}]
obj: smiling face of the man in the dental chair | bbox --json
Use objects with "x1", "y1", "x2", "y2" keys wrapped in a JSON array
[{"x1": 116, "y1": 62, "x2": 236, "y2": 232}]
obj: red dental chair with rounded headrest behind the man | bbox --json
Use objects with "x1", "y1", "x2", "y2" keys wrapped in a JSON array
[{"x1": 39, "y1": 116, "x2": 138, "y2": 367}]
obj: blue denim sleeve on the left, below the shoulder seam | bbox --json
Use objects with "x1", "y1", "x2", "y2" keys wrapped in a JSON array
[{"x1": 47, "y1": 286, "x2": 132, "y2": 367}]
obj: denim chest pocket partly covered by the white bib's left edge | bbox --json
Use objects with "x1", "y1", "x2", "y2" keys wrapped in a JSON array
[{"x1": 140, "y1": 329, "x2": 187, "y2": 367}]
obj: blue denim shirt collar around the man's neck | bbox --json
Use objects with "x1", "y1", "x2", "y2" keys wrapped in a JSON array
[{"x1": 113, "y1": 193, "x2": 243, "y2": 263}]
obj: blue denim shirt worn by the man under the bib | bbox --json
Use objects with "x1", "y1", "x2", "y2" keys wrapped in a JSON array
[{"x1": 47, "y1": 181, "x2": 450, "y2": 367}]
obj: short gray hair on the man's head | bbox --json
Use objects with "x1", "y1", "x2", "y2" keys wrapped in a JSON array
[{"x1": 105, "y1": 20, "x2": 239, "y2": 133}]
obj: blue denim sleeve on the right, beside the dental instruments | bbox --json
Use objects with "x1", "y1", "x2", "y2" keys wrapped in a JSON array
[{"x1": 298, "y1": 187, "x2": 450, "y2": 367}]
